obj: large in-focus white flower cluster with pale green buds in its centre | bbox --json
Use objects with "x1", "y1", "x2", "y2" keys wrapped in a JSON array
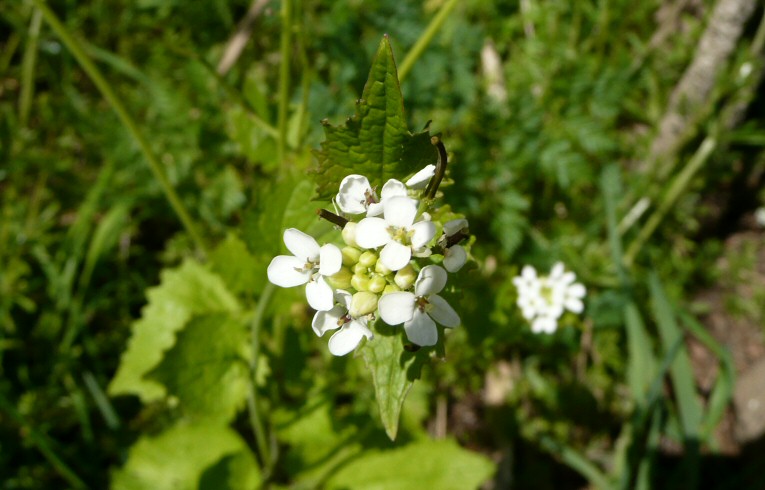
[{"x1": 268, "y1": 165, "x2": 468, "y2": 356}]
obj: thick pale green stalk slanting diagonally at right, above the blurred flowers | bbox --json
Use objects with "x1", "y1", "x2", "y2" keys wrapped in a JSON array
[{"x1": 624, "y1": 136, "x2": 717, "y2": 265}]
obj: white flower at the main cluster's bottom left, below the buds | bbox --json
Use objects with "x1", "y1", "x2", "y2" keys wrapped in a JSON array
[{"x1": 311, "y1": 289, "x2": 374, "y2": 356}]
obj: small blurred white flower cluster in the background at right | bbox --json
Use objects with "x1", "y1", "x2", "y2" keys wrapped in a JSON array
[{"x1": 513, "y1": 262, "x2": 587, "y2": 333}]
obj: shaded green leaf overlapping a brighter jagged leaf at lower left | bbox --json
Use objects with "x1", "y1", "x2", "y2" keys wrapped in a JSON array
[{"x1": 147, "y1": 313, "x2": 249, "y2": 422}]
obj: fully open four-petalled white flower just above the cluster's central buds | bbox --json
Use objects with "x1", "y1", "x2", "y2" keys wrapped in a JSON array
[{"x1": 356, "y1": 196, "x2": 436, "y2": 271}]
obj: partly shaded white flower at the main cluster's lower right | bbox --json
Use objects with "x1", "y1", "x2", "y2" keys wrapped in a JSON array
[{"x1": 378, "y1": 265, "x2": 460, "y2": 346}]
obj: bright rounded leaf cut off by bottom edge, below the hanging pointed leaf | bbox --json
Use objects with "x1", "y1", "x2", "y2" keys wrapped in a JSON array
[{"x1": 325, "y1": 440, "x2": 495, "y2": 490}]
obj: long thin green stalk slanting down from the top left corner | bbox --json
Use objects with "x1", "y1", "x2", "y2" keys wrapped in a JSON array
[{"x1": 32, "y1": 0, "x2": 207, "y2": 256}]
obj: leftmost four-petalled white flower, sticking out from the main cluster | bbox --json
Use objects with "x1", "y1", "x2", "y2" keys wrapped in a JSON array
[{"x1": 268, "y1": 228, "x2": 343, "y2": 311}]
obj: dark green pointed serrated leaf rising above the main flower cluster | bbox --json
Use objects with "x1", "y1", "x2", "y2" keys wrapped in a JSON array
[{"x1": 314, "y1": 37, "x2": 437, "y2": 199}]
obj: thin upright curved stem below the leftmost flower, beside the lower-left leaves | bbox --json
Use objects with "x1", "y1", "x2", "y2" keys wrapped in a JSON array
[{"x1": 247, "y1": 282, "x2": 276, "y2": 478}]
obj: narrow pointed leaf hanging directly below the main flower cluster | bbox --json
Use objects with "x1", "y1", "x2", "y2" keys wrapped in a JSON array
[{"x1": 362, "y1": 325, "x2": 430, "y2": 440}]
